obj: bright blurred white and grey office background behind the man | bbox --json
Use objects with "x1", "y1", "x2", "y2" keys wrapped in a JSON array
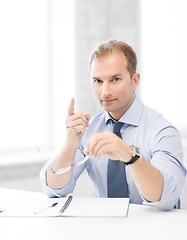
[{"x1": 0, "y1": 0, "x2": 187, "y2": 208}]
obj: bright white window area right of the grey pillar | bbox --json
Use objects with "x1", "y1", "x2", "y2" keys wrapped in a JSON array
[{"x1": 141, "y1": 0, "x2": 187, "y2": 144}]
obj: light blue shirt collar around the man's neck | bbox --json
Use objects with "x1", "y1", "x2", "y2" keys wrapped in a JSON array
[{"x1": 105, "y1": 97, "x2": 144, "y2": 126}]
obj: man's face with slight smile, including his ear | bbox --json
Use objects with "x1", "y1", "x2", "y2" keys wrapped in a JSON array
[{"x1": 91, "y1": 52, "x2": 139, "y2": 120}]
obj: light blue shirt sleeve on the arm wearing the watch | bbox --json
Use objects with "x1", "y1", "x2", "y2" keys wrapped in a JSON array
[{"x1": 142, "y1": 126, "x2": 186, "y2": 210}]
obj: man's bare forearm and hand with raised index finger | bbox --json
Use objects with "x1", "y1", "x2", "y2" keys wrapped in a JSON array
[{"x1": 47, "y1": 98, "x2": 90, "y2": 189}]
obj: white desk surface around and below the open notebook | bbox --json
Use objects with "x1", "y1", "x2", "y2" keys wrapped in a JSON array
[{"x1": 0, "y1": 189, "x2": 187, "y2": 240}]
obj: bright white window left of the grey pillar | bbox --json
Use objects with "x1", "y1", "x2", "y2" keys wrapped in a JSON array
[{"x1": 0, "y1": 0, "x2": 75, "y2": 162}]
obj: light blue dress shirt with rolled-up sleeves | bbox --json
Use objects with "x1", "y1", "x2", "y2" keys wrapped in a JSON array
[{"x1": 40, "y1": 97, "x2": 186, "y2": 210}]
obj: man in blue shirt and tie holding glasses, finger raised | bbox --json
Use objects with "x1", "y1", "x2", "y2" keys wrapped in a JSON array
[{"x1": 41, "y1": 40, "x2": 186, "y2": 210}]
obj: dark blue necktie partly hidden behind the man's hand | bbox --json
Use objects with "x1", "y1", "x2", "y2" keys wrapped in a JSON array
[{"x1": 107, "y1": 122, "x2": 129, "y2": 198}]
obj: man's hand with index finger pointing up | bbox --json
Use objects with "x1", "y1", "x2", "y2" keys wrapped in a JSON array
[{"x1": 66, "y1": 98, "x2": 90, "y2": 148}]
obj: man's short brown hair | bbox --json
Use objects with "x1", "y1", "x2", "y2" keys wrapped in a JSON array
[{"x1": 90, "y1": 40, "x2": 137, "y2": 78}]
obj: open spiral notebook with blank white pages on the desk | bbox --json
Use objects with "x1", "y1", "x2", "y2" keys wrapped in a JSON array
[{"x1": 0, "y1": 196, "x2": 129, "y2": 217}]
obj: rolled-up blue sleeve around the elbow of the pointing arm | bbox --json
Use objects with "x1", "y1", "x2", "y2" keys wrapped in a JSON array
[{"x1": 40, "y1": 147, "x2": 86, "y2": 197}]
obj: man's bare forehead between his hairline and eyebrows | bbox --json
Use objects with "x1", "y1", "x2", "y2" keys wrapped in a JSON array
[{"x1": 91, "y1": 52, "x2": 127, "y2": 76}]
